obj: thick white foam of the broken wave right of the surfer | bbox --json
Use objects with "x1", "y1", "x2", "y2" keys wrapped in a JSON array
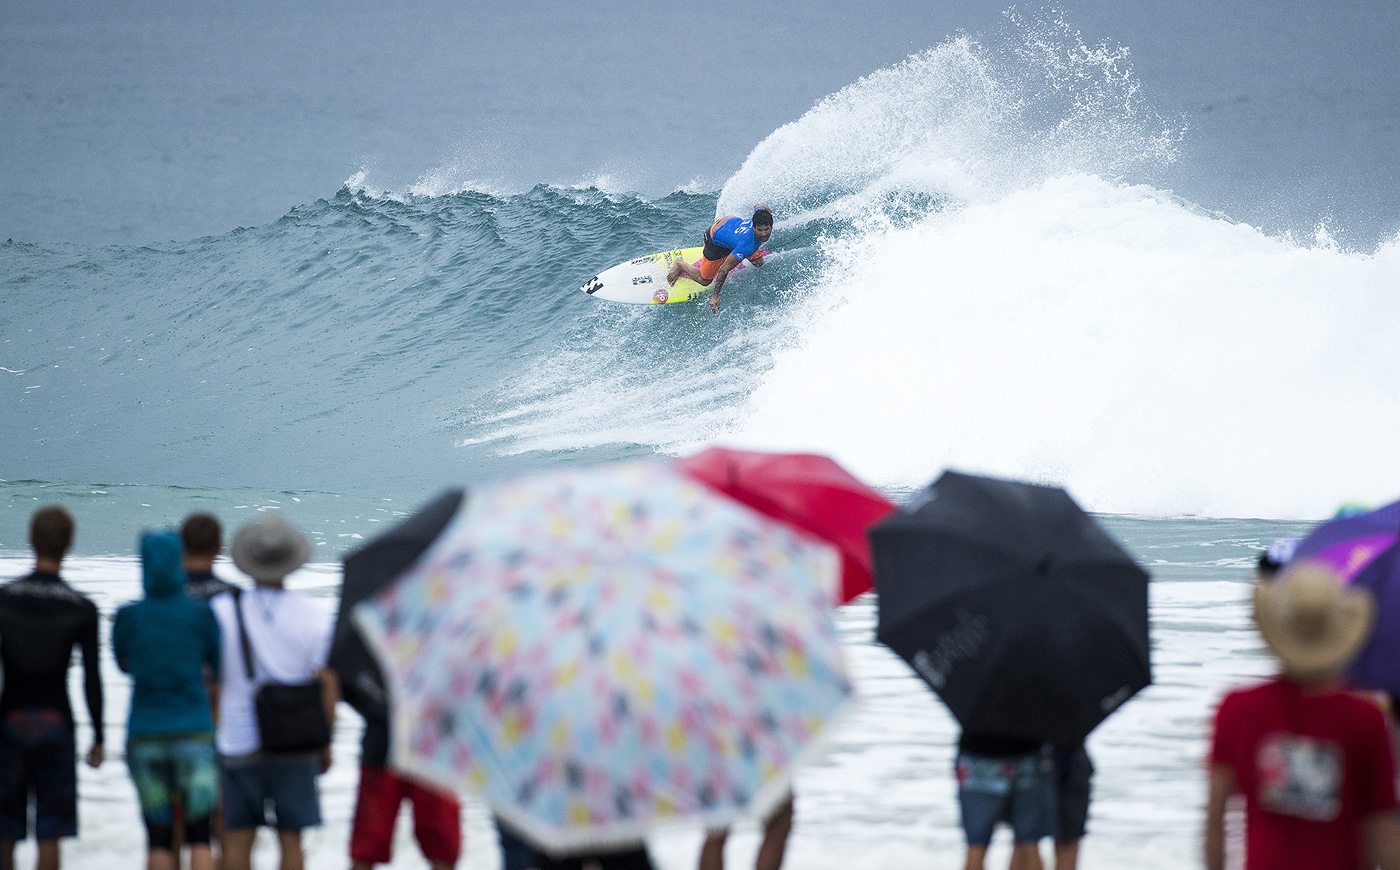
[{"x1": 734, "y1": 175, "x2": 1400, "y2": 517}]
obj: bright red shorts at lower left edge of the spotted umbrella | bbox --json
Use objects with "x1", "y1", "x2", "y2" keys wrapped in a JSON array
[{"x1": 350, "y1": 768, "x2": 462, "y2": 864}]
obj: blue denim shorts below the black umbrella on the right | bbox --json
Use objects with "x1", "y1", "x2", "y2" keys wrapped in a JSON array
[{"x1": 953, "y1": 752, "x2": 1056, "y2": 846}]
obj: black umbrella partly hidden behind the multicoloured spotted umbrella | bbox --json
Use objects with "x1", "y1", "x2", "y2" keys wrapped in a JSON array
[{"x1": 330, "y1": 489, "x2": 465, "y2": 720}]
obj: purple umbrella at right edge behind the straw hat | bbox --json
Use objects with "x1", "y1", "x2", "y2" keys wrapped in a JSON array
[{"x1": 1294, "y1": 502, "x2": 1400, "y2": 695}]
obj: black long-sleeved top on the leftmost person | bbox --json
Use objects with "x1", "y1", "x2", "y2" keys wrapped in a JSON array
[{"x1": 0, "y1": 572, "x2": 102, "y2": 744}]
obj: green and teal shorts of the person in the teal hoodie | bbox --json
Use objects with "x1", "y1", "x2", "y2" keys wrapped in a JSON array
[{"x1": 126, "y1": 734, "x2": 218, "y2": 825}]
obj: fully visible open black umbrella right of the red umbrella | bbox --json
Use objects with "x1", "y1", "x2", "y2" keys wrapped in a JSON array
[{"x1": 869, "y1": 471, "x2": 1152, "y2": 747}]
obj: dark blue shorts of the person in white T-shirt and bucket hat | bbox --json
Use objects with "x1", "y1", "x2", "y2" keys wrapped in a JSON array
[{"x1": 218, "y1": 755, "x2": 321, "y2": 831}]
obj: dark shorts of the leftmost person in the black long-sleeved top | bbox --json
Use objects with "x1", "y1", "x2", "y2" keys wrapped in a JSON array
[{"x1": 0, "y1": 710, "x2": 78, "y2": 841}]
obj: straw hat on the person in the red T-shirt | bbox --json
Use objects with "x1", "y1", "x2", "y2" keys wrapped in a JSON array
[{"x1": 1254, "y1": 562, "x2": 1376, "y2": 679}]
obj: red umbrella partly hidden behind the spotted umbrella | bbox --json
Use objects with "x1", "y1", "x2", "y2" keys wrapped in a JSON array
[{"x1": 676, "y1": 447, "x2": 895, "y2": 604}]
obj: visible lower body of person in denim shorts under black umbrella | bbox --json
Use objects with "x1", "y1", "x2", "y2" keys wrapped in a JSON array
[{"x1": 955, "y1": 731, "x2": 1056, "y2": 870}]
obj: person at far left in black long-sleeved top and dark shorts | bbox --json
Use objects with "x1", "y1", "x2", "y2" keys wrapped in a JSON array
[{"x1": 0, "y1": 504, "x2": 105, "y2": 870}]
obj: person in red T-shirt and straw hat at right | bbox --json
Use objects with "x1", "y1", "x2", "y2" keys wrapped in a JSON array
[{"x1": 1205, "y1": 562, "x2": 1400, "y2": 870}]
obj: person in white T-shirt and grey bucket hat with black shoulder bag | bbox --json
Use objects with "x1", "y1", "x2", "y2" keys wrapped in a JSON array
[{"x1": 210, "y1": 514, "x2": 339, "y2": 870}]
